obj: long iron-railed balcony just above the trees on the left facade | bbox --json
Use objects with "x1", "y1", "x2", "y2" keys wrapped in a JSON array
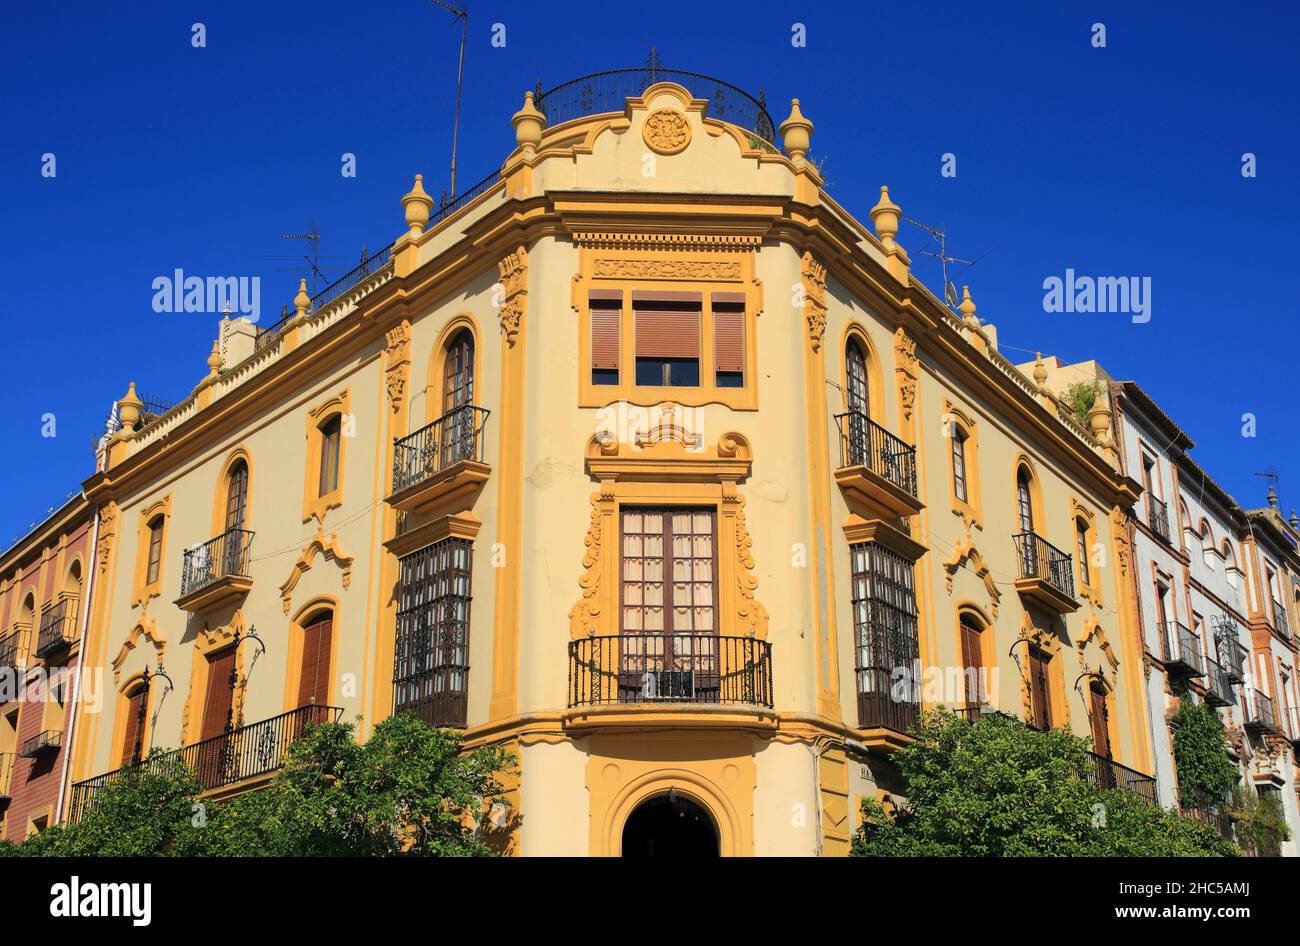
[{"x1": 68, "y1": 703, "x2": 343, "y2": 821}]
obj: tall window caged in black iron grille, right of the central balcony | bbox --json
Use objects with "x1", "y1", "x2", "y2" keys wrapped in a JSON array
[{"x1": 849, "y1": 542, "x2": 920, "y2": 733}]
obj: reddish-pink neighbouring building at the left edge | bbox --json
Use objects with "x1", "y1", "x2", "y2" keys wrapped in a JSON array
[{"x1": 0, "y1": 495, "x2": 95, "y2": 842}]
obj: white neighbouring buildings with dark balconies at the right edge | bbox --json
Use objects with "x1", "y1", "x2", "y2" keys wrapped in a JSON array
[{"x1": 1021, "y1": 359, "x2": 1300, "y2": 854}]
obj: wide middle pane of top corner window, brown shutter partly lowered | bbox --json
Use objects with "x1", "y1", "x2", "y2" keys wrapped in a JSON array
[{"x1": 632, "y1": 290, "x2": 701, "y2": 387}]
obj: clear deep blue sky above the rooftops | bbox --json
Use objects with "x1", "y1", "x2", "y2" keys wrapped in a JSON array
[{"x1": 0, "y1": 0, "x2": 1300, "y2": 547}]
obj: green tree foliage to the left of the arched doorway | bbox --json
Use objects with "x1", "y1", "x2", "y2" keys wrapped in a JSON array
[{"x1": 0, "y1": 715, "x2": 514, "y2": 856}]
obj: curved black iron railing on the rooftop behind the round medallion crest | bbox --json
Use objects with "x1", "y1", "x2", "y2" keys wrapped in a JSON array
[{"x1": 533, "y1": 60, "x2": 776, "y2": 142}]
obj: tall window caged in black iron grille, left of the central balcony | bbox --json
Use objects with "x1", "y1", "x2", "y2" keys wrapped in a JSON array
[{"x1": 393, "y1": 539, "x2": 473, "y2": 728}]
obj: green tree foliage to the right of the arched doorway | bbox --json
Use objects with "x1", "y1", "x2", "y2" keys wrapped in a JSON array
[{"x1": 853, "y1": 710, "x2": 1238, "y2": 856}]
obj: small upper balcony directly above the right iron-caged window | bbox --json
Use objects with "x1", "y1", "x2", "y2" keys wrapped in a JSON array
[{"x1": 835, "y1": 411, "x2": 926, "y2": 520}]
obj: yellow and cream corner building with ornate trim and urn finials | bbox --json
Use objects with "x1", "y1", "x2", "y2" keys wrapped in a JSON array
[{"x1": 68, "y1": 77, "x2": 1153, "y2": 855}]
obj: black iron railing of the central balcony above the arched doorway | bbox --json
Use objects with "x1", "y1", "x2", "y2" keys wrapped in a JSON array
[{"x1": 568, "y1": 633, "x2": 772, "y2": 708}]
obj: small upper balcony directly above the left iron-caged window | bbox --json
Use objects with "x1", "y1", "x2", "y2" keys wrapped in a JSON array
[{"x1": 387, "y1": 404, "x2": 491, "y2": 512}]
